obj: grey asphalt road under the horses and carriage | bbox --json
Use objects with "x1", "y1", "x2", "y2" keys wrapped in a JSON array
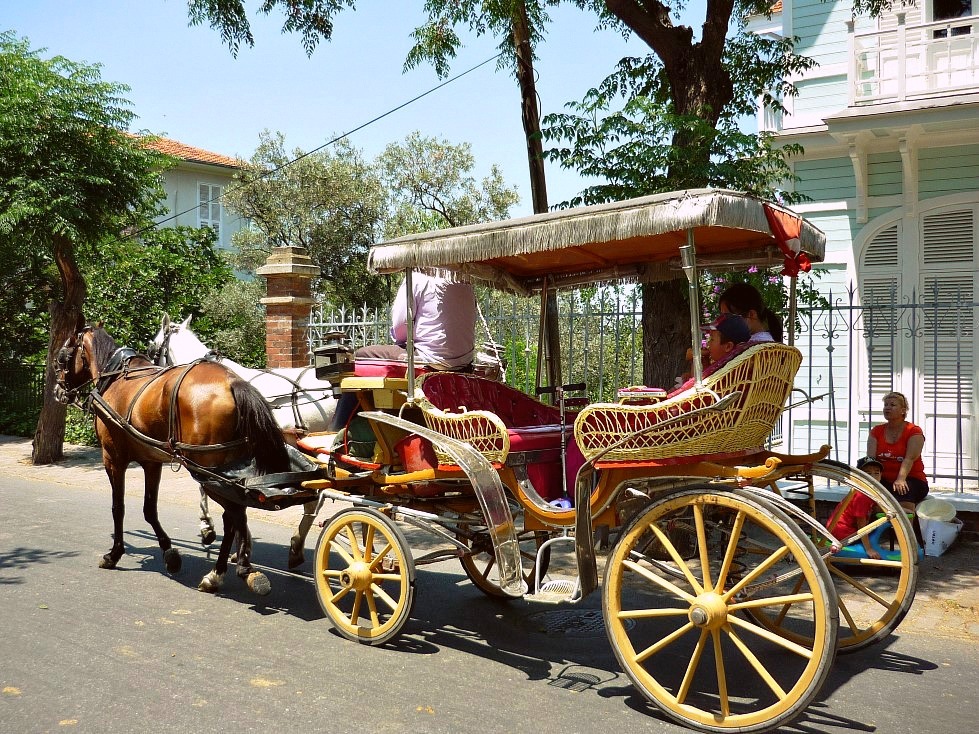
[{"x1": 0, "y1": 474, "x2": 979, "y2": 734}]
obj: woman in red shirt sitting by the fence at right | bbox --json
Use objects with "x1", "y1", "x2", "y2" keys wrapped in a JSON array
[{"x1": 867, "y1": 392, "x2": 928, "y2": 509}]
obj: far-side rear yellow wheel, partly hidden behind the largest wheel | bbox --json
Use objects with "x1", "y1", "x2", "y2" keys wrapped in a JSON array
[{"x1": 772, "y1": 461, "x2": 919, "y2": 653}]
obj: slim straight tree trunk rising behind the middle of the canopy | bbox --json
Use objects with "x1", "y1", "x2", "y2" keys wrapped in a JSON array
[{"x1": 513, "y1": 2, "x2": 562, "y2": 392}]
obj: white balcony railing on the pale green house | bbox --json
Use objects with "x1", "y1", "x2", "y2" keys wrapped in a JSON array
[{"x1": 847, "y1": 13, "x2": 979, "y2": 107}]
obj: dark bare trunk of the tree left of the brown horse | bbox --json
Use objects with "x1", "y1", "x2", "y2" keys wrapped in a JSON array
[{"x1": 31, "y1": 237, "x2": 85, "y2": 464}]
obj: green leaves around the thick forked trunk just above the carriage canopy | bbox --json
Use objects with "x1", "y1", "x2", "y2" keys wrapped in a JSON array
[{"x1": 543, "y1": 32, "x2": 813, "y2": 206}]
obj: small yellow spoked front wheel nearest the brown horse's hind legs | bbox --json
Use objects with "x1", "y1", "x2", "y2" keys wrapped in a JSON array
[{"x1": 314, "y1": 509, "x2": 415, "y2": 645}]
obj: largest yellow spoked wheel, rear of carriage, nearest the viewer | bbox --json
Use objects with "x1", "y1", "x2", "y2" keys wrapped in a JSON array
[{"x1": 602, "y1": 485, "x2": 839, "y2": 732}]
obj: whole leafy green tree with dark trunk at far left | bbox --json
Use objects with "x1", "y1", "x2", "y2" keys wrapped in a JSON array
[{"x1": 0, "y1": 33, "x2": 171, "y2": 463}]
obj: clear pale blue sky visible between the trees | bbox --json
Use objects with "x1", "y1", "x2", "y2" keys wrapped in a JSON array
[{"x1": 0, "y1": 0, "x2": 705, "y2": 215}]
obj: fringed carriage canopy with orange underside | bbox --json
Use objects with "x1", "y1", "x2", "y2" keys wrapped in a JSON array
[{"x1": 368, "y1": 189, "x2": 826, "y2": 295}]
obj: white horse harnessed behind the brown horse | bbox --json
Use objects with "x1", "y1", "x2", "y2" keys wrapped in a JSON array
[{"x1": 149, "y1": 315, "x2": 337, "y2": 568}]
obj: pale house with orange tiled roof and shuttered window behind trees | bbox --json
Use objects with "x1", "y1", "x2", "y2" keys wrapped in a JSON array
[{"x1": 142, "y1": 138, "x2": 247, "y2": 249}]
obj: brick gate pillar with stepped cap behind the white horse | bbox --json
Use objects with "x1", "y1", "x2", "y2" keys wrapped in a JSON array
[{"x1": 255, "y1": 246, "x2": 320, "y2": 369}]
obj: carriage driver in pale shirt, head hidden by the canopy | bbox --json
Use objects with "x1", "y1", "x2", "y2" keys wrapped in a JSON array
[{"x1": 332, "y1": 271, "x2": 477, "y2": 431}]
